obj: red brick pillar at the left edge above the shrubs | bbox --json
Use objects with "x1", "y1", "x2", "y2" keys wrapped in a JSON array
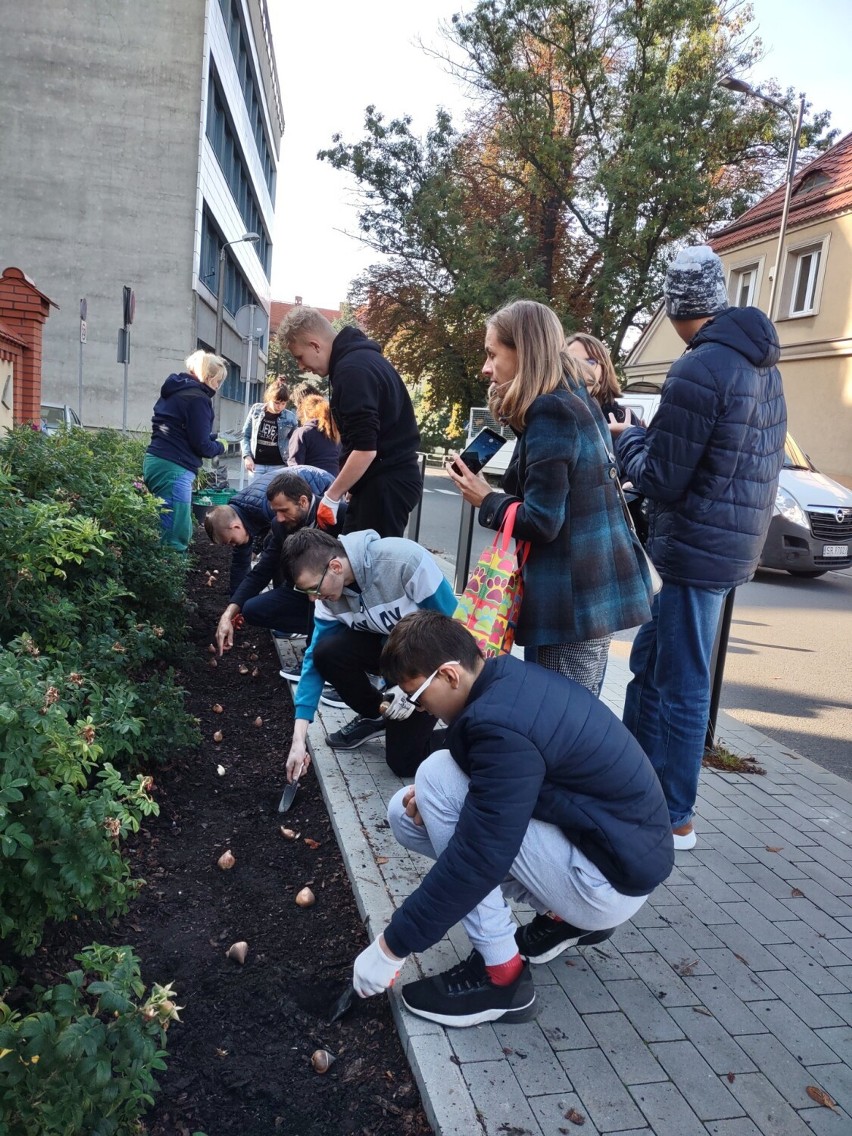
[{"x1": 0, "y1": 268, "x2": 57, "y2": 424}]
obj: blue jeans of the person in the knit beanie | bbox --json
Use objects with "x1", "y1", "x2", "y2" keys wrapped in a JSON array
[{"x1": 621, "y1": 582, "x2": 729, "y2": 828}]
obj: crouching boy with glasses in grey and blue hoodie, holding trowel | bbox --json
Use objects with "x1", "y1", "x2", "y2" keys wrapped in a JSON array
[{"x1": 282, "y1": 528, "x2": 456, "y2": 780}]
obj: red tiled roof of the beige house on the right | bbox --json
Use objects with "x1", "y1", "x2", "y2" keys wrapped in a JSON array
[{"x1": 710, "y1": 134, "x2": 852, "y2": 252}]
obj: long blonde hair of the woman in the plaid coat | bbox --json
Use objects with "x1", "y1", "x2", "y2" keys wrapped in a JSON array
[{"x1": 487, "y1": 300, "x2": 582, "y2": 429}]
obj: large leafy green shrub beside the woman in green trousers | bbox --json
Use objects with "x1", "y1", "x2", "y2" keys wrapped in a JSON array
[{"x1": 0, "y1": 428, "x2": 198, "y2": 767}]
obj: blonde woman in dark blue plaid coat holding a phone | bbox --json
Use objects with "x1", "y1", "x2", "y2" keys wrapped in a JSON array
[{"x1": 448, "y1": 300, "x2": 652, "y2": 694}]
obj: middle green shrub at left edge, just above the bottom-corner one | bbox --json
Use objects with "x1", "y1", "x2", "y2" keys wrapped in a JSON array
[{"x1": 0, "y1": 650, "x2": 158, "y2": 954}]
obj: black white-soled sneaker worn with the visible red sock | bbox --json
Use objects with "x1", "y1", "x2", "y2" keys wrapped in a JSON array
[{"x1": 402, "y1": 951, "x2": 538, "y2": 1026}]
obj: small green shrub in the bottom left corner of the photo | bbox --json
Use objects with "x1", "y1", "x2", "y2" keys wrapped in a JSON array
[{"x1": 0, "y1": 944, "x2": 181, "y2": 1136}]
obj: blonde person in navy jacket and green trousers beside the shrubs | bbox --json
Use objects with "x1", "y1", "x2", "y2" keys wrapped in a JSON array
[{"x1": 142, "y1": 351, "x2": 227, "y2": 552}]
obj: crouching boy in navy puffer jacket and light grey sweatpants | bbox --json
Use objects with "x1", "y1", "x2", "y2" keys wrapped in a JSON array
[{"x1": 352, "y1": 611, "x2": 674, "y2": 1026}]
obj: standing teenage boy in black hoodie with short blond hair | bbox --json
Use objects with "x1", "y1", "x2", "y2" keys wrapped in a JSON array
[{"x1": 278, "y1": 307, "x2": 423, "y2": 536}]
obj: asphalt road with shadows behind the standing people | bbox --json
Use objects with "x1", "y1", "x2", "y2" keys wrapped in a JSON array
[{"x1": 420, "y1": 471, "x2": 852, "y2": 779}]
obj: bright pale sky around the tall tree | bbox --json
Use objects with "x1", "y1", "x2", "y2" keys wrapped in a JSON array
[{"x1": 268, "y1": 0, "x2": 852, "y2": 308}]
